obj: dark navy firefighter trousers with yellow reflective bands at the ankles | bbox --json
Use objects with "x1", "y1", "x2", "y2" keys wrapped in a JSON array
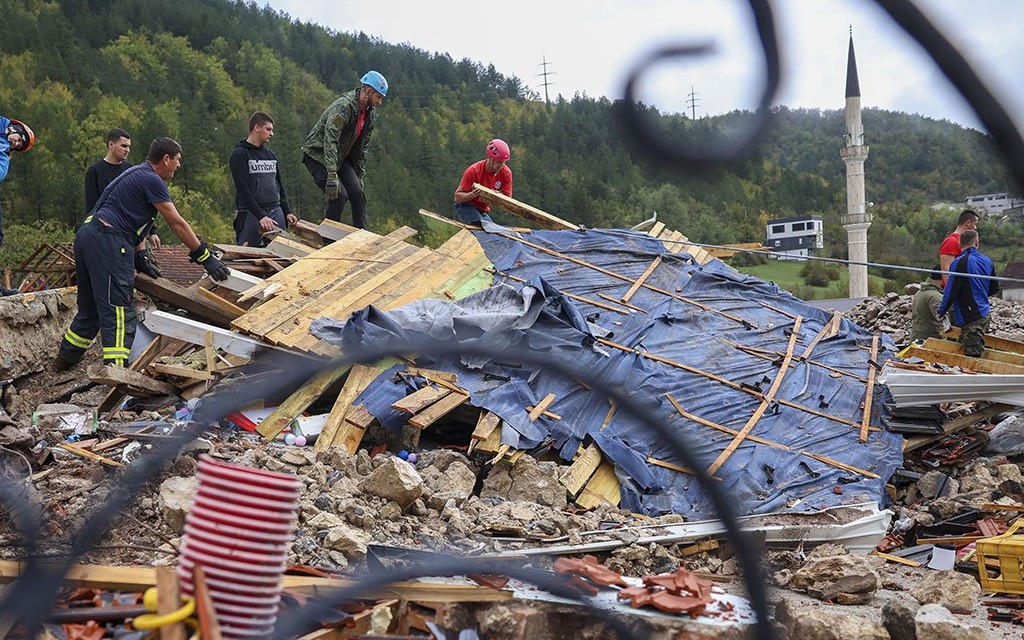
[{"x1": 59, "y1": 218, "x2": 135, "y2": 367}]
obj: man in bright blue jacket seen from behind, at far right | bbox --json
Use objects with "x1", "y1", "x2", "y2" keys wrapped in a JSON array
[{"x1": 939, "y1": 229, "x2": 999, "y2": 357}]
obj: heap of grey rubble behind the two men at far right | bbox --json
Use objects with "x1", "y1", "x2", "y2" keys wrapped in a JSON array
[{"x1": 844, "y1": 286, "x2": 1024, "y2": 344}]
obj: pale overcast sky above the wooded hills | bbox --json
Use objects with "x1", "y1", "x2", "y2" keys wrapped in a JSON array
[{"x1": 260, "y1": 0, "x2": 1024, "y2": 128}]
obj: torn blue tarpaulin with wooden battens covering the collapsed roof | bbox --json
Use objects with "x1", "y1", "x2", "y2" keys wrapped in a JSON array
[{"x1": 311, "y1": 229, "x2": 902, "y2": 519}]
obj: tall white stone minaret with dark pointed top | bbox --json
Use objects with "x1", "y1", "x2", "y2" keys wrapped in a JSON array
[{"x1": 840, "y1": 27, "x2": 871, "y2": 298}]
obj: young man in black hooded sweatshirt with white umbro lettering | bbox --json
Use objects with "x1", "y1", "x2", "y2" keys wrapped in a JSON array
[{"x1": 227, "y1": 112, "x2": 298, "y2": 247}]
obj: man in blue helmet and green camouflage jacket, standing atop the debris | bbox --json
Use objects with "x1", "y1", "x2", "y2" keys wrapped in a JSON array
[{"x1": 302, "y1": 71, "x2": 387, "y2": 229}]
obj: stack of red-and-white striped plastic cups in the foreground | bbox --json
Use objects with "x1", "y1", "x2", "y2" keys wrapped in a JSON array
[{"x1": 177, "y1": 456, "x2": 302, "y2": 639}]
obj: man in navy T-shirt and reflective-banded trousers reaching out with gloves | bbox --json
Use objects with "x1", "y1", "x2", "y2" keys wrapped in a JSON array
[{"x1": 55, "y1": 138, "x2": 229, "y2": 371}]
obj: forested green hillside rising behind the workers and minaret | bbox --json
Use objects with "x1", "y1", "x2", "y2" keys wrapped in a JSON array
[{"x1": 0, "y1": 0, "x2": 1020, "y2": 284}]
